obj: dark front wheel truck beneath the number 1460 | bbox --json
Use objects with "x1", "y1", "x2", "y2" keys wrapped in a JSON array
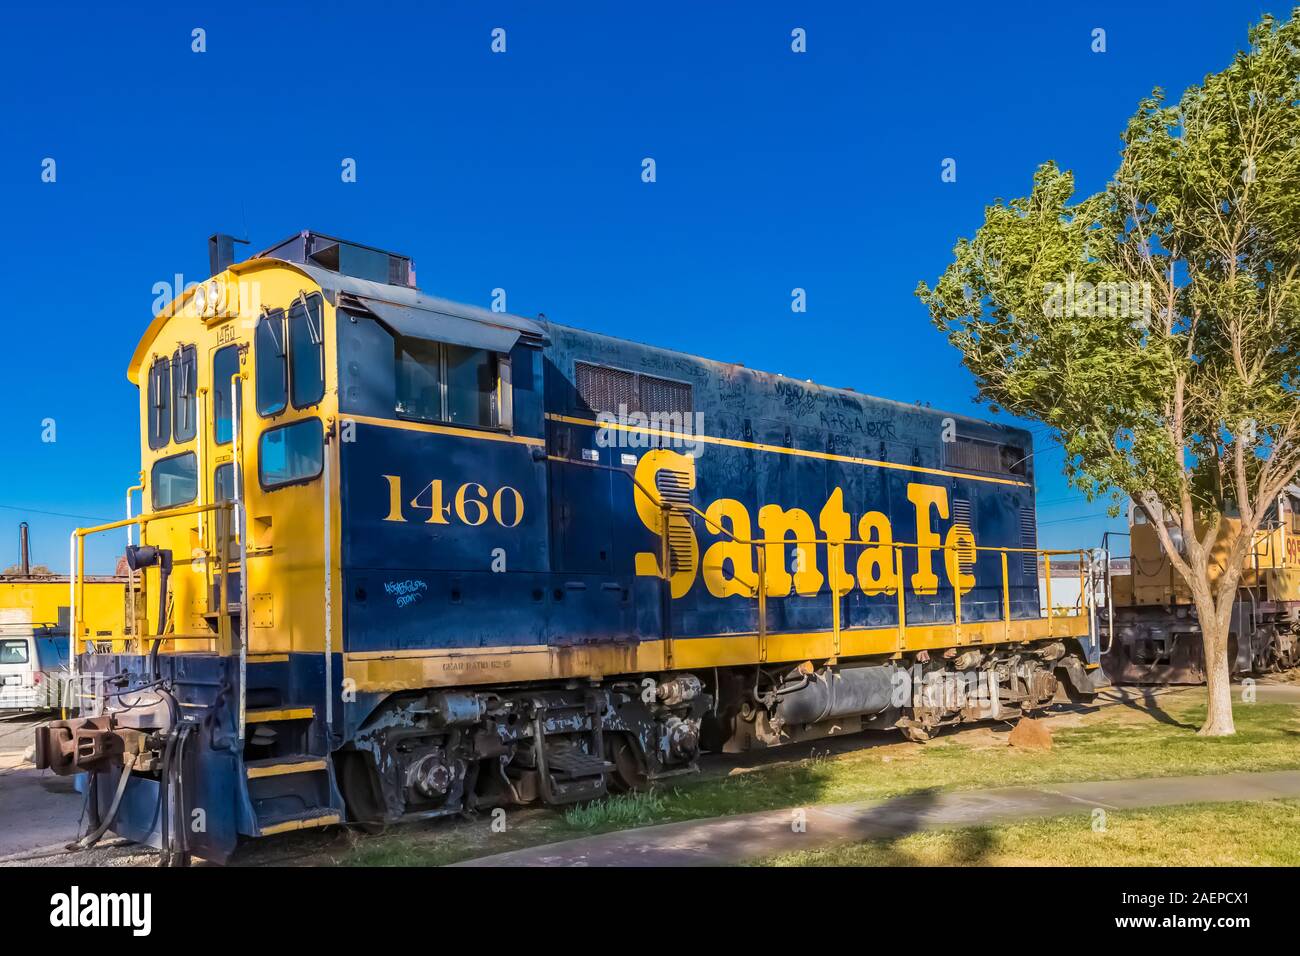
[{"x1": 335, "y1": 674, "x2": 710, "y2": 826}]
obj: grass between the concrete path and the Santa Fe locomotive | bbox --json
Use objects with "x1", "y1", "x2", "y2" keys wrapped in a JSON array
[{"x1": 322, "y1": 688, "x2": 1300, "y2": 866}]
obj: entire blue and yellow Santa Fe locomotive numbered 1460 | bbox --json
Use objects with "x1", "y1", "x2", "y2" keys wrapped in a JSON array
[{"x1": 38, "y1": 233, "x2": 1097, "y2": 861}]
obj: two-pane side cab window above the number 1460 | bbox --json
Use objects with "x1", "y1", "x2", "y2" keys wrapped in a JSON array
[{"x1": 395, "y1": 337, "x2": 499, "y2": 428}]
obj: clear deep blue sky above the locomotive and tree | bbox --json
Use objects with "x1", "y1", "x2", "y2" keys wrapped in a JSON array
[{"x1": 0, "y1": 0, "x2": 1287, "y2": 570}]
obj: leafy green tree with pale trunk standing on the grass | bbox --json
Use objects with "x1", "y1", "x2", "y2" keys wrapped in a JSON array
[{"x1": 917, "y1": 8, "x2": 1300, "y2": 735}]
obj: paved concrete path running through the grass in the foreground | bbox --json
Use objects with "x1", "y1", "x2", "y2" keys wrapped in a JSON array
[{"x1": 455, "y1": 770, "x2": 1300, "y2": 866}]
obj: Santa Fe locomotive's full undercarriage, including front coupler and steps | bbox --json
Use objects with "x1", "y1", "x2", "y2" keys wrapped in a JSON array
[{"x1": 30, "y1": 640, "x2": 1095, "y2": 860}]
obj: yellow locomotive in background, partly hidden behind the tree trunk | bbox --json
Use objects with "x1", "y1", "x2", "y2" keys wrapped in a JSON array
[{"x1": 1101, "y1": 485, "x2": 1300, "y2": 684}]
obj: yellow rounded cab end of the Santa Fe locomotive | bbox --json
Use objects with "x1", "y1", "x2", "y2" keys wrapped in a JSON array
[{"x1": 129, "y1": 243, "x2": 338, "y2": 659}]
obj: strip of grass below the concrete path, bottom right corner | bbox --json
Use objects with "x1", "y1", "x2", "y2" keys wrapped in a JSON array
[{"x1": 757, "y1": 800, "x2": 1300, "y2": 866}]
